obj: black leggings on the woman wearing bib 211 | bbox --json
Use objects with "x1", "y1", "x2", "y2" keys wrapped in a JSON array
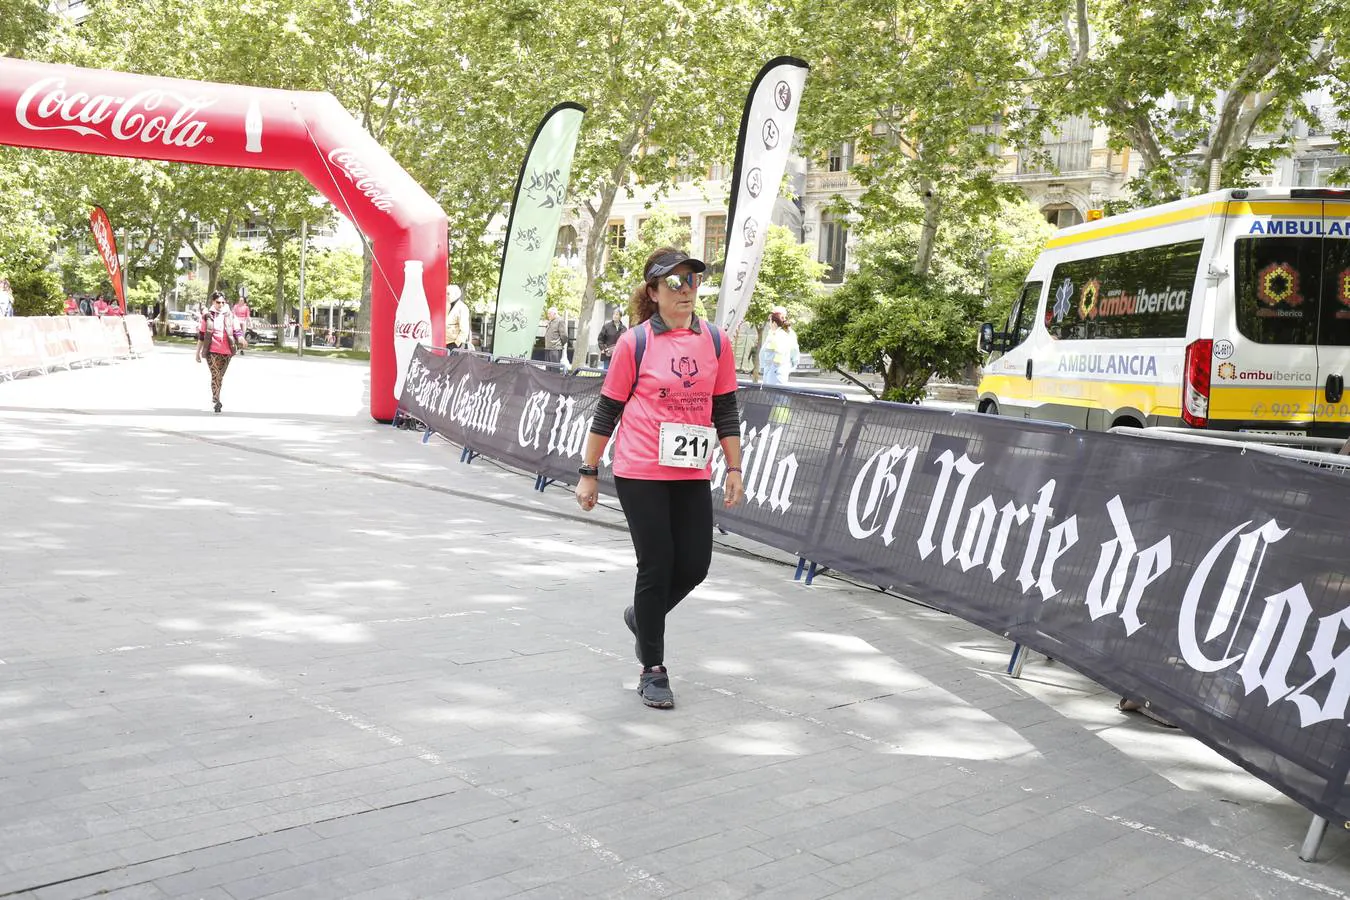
[{"x1": 614, "y1": 476, "x2": 713, "y2": 667}]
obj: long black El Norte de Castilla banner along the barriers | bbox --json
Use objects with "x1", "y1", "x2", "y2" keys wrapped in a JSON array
[{"x1": 401, "y1": 348, "x2": 1350, "y2": 822}]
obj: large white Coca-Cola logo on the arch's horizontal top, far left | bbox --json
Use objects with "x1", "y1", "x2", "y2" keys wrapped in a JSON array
[{"x1": 15, "y1": 78, "x2": 216, "y2": 147}]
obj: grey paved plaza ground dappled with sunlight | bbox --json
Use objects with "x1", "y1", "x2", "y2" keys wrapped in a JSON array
[{"x1": 0, "y1": 347, "x2": 1350, "y2": 900}]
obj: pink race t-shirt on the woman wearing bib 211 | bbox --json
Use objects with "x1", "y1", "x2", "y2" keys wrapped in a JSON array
[{"x1": 601, "y1": 320, "x2": 736, "y2": 482}]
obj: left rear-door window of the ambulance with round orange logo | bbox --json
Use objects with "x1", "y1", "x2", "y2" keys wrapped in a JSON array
[{"x1": 1233, "y1": 237, "x2": 1322, "y2": 344}]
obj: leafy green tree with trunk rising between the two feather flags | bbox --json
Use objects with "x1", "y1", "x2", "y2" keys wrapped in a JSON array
[{"x1": 522, "y1": 0, "x2": 774, "y2": 358}]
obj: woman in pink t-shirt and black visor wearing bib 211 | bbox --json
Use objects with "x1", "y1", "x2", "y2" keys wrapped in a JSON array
[{"x1": 576, "y1": 247, "x2": 745, "y2": 708}]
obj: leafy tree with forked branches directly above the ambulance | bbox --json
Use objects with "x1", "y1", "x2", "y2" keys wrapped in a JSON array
[{"x1": 1035, "y1": 0, "x2": 1350, "y2": 202}]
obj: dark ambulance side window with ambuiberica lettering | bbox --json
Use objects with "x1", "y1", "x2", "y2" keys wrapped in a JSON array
[{"x1": 1045, "y1": 240, "x2": 1203, "y2": 340}]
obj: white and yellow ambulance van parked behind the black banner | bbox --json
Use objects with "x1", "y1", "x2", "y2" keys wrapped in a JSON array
[{"x1": 979, "y1": 189, "x2": 1350, "y2": 437}]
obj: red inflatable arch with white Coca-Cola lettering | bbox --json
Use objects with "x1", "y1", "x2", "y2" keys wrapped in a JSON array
[{"x1": 0, "y1": 57, "x2": 448, "y2": 421}]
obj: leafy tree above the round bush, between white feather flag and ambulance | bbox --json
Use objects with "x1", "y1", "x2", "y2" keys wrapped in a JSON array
[{"x1": 783, "y1": 0, "x2": 1057, "y2": 277}]
